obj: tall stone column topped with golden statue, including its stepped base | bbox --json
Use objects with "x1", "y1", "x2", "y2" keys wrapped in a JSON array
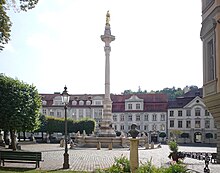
[{"x1": 98, "y1": 11, "x2": 116, "y2": 137}]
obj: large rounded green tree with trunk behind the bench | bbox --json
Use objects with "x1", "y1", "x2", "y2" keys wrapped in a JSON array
[{"x1": 0, "y1": 74, "x2": 41, "y2": 150}]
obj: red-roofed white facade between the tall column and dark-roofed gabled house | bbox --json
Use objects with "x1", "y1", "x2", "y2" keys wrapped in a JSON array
[{"x1": 112, "y1": 94, "x2": 168, "y2": 142}]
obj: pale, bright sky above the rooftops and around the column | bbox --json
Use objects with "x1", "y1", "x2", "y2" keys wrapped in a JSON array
[{"x1": 0, "y1": 0, "x2": 203, "y2": 94}]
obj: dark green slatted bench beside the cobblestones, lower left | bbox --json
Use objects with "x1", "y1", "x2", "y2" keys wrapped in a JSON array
[{"x1": 0, "y1": 151, "x2": 42, "y2": 168}]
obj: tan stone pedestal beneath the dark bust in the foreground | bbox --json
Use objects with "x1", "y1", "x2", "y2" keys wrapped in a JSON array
[{"x1": 130, "y1": 138, "x2": 139, "y2": 173}]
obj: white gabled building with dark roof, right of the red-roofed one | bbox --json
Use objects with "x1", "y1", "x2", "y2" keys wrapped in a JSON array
[{"x1": 168, "y1": 89, "x2": 217, "y2": 143}]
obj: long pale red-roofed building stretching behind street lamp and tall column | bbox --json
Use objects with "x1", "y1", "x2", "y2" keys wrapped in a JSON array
[{"x1": 41, "y1": 93, "x2": 168, "y2": 142}]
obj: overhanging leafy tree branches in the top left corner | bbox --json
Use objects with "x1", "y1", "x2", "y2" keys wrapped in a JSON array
[{"x1": 0, "y1": 0, "x2": 38, "y2": 51}]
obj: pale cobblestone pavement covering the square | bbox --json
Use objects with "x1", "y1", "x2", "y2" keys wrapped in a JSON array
[{"x1": 1, "y1": 144, "x2": 220, "y2": 173}]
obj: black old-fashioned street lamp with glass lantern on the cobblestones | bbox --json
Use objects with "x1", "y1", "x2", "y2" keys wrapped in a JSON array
[{"x1": 61, "y1": 86, "x2": 70, "y2": 169}]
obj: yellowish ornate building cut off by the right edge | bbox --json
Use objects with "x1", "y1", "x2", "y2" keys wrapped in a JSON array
[{"x1": 200, "y1": 0, "x2": 220, "y2": 163}]
